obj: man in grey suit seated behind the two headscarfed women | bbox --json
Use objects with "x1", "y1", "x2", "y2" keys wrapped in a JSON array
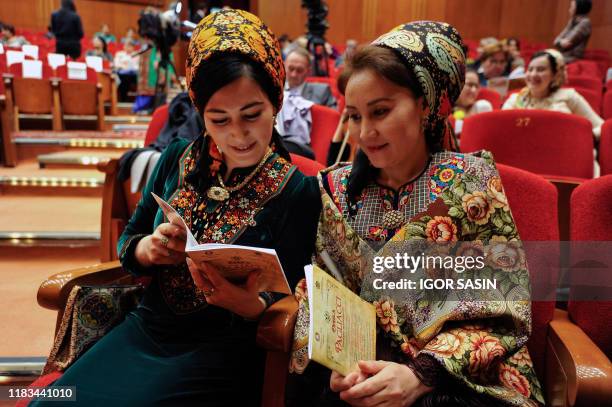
[{"x1": 285, "y1": 46, "x2": 336, "y2": 109}]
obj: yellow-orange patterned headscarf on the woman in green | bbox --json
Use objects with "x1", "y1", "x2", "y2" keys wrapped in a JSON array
[{"x1": 186, "y1": 9, "x2": 285, "y2": 111}]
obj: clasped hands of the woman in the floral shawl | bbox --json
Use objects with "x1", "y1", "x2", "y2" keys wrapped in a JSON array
[{"x1": 340, "y1": 360, "x2": 433, "y2": 407}]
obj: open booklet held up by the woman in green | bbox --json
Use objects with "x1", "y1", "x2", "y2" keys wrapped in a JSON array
[{"x1": 151, "y1": 192, "x2": 291, "y2": 294}]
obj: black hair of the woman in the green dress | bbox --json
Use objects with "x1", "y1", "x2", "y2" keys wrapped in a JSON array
[{"x1": 186, "y1": 53, "x2": 291, "y2": 191}]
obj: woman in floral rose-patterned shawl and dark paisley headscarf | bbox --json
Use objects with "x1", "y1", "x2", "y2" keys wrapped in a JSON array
[{"x1": 287, "y1": 21, "x2": 543, "y2": 407}]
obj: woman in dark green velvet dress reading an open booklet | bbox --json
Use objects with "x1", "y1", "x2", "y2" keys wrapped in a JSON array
[{"x1": 33, "y1": 10, "x2": 320, "y2": 407}]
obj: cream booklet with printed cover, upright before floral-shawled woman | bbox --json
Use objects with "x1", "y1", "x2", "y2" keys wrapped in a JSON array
[{"x1": 304, "y1": 265, "x2": 376, "y2": 376}]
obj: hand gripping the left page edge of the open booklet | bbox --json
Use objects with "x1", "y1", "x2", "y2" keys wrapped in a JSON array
[{"x1": 134, "y1": 223, "x2": 186, "y2": 267}]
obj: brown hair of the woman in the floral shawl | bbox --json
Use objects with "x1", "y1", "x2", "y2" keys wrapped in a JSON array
[{"x1": 338, "y1": 45, "x2": 430, "y2": 213}]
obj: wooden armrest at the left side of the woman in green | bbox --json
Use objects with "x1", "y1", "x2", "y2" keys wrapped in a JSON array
[{"x1": 36, "y1": 261, "x2": 132, "y2": 311}]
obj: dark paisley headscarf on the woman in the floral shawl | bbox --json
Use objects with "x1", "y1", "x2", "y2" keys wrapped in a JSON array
[{"x1": 372, "y1": 21, "x2": 465, "y2": 150}]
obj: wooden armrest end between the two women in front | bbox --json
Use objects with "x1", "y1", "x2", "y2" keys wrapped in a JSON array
[{"x1": 257, "y1": 295, "x2": 298, "y2": 352}]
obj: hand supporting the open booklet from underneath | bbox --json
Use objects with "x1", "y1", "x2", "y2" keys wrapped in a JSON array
[{"x1": 187, "y1": 258, "x2": 266, "y2": 319}]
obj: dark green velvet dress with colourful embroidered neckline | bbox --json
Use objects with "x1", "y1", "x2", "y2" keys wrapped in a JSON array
[{"x1": 31, "y1": 141, "x2": 321, "y2": 407}]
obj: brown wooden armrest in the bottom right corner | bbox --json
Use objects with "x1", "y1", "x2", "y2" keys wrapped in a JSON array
[{"x1": 545, "y1": 309, "x2": 612, "y2": 406}]
